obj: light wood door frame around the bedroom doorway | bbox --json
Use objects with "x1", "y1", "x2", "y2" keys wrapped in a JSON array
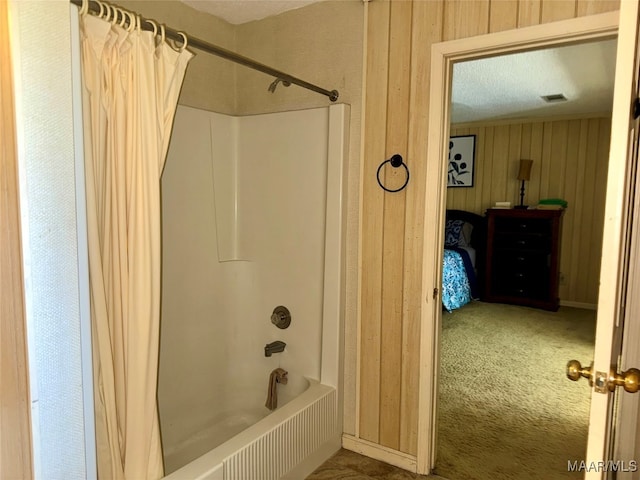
[{"x1": 416, "y1": 11, "x2": 619, "y2": 474}]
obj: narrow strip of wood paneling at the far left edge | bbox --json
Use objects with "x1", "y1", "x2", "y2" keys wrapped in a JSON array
[{"x1": 0, "y1": 0, "x2": 33, "y2": 479}]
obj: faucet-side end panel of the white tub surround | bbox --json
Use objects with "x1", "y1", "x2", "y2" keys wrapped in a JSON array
[{"x1": 234, "y1": 108, "x2": 329, "y2": 380}]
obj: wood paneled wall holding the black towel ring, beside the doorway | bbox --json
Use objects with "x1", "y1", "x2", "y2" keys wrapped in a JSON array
[{"x1": 355, "y1": 0, "x2": 619, "y2": 455}]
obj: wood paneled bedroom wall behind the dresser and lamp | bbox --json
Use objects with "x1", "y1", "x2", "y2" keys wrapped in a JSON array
[{"x1": 447, "y1": 117, "x2": 611, "y2": 305}]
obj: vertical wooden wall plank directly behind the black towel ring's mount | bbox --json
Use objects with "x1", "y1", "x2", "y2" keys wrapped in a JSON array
[{"x1": 379, "y1": 2, "x2": 412, "y2": 450}]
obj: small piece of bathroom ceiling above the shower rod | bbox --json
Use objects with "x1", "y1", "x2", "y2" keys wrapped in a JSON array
[{"x1": 181, "y1": 0, "x2": 319, "y2": 25}]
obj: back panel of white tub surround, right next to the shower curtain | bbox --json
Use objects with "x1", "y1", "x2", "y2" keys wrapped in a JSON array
[{"x1": 158, "y1": 107, "x2": 233, "y2": 450}]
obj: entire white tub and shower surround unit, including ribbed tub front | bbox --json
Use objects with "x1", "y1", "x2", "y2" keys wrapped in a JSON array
[{"x1": 158, "y1": 105, "x2": 349, "y2": 480}]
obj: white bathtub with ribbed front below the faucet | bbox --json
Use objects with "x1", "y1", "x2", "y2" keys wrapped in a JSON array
[{"x1": 164, "y1": 374, "x2": 340, "y2": 480}]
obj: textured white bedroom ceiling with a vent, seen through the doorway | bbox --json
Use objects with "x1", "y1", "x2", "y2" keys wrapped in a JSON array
[{"x1": 451, "y1": 40, "x2": 616, "y2": 123}]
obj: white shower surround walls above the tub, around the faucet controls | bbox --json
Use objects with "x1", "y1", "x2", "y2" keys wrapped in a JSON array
[{"x1": 158, "y1": 106, "x2": 340, "y2": 464}]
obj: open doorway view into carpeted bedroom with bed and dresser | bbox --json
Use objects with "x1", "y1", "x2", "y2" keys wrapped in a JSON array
[{"x1": 435, "y1": 39, "x2": 616, "y2": 480}]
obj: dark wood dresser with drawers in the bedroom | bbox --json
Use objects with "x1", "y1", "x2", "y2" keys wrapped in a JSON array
[{"x1": 484, "y1": 208, "x2": 563, "y2": 311}]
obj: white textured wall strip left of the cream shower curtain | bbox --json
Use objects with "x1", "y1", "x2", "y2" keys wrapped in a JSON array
[{"x1": 9, "y1": 0, "x2": 96, "y2": 479}]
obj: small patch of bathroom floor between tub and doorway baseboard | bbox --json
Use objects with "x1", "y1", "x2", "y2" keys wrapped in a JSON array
[{"x1": 306, "y1": 448, "x2": 427, "y2": 480}]
